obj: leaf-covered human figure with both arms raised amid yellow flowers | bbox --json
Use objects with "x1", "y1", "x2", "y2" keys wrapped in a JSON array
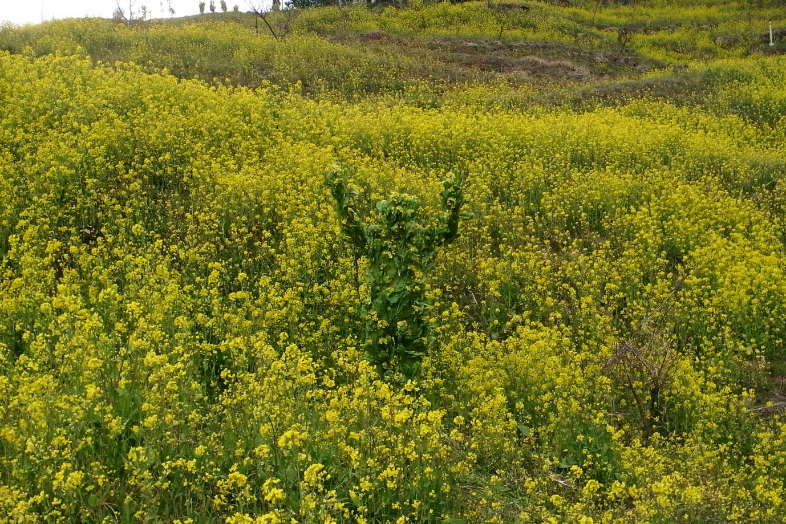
[{"x1": 326, "y1": 170, "x2": 470, "y2": 379}]
